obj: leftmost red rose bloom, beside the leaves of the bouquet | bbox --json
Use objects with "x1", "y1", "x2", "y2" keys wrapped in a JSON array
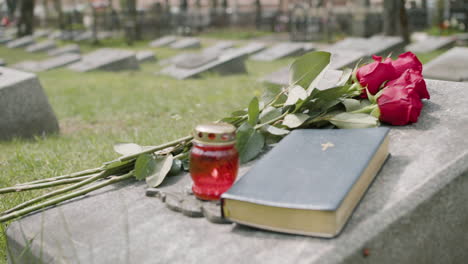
[{"x1": 356, "y1": 55, "x2": 398, "y2": 97}]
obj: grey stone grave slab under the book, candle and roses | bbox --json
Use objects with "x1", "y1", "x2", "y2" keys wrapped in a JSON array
[{"x1": 7, "y1": 80, "x2": 468, "y2": 264}]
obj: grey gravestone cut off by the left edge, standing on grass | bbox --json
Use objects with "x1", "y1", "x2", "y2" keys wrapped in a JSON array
[{"x1": 0, "y1": 67, "x2": 59, "y2": 140}]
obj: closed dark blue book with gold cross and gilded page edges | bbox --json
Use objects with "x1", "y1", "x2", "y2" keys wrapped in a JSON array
[{"x1": 221, "y1": 128, "x2": 389, "y2": 237}]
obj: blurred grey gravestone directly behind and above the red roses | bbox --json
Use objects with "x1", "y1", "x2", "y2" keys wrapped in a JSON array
[{"x1": 329, "y1": 36, "x2": 404, "y2": 57}]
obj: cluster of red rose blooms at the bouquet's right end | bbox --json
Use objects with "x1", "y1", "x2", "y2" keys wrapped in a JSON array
[{"x1": 353, "y1": 52, "x2": 430, "y2": 126}]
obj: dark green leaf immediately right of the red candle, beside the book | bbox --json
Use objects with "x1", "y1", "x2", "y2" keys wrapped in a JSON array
[{"x1": 236, "y1": 123, "x2": 265, "y2": 163}]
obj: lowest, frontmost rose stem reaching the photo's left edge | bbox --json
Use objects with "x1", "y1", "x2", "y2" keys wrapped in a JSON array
[{"x1": 0, "y1": 171, "x2": 133, "y2": 223}]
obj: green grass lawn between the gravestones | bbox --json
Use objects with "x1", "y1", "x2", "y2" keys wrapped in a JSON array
[{"x1": 0, "y1": 34, "x2": 446, "y2": 263}]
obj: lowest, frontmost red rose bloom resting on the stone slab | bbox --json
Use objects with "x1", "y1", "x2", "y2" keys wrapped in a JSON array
[{"x1": 377, "y1": 86, "x2": 423, "y2": 126}]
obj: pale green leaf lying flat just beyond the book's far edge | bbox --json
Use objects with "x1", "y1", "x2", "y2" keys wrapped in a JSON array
[{"x1": 329, "y1": 113, "x2": 379, "y2": 128}]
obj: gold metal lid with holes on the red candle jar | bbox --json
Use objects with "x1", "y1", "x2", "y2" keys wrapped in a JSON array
[{"x1": 193, "y1": 123, "x2": 236, "y2": 146}]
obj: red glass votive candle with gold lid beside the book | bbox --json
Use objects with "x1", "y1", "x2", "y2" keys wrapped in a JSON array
[{"x1": 190, "y1": 123, "x2": 239, "y2": 200}]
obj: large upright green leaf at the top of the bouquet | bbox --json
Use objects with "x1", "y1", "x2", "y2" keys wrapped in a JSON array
[{"x1": 289, "y1": 51, "x2": 331, "y2": 87}]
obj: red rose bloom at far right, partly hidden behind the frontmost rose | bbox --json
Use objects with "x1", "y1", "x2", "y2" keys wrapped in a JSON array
[{"x1": 386, "y1": 69, "x2": 430, "y2": 99}]
